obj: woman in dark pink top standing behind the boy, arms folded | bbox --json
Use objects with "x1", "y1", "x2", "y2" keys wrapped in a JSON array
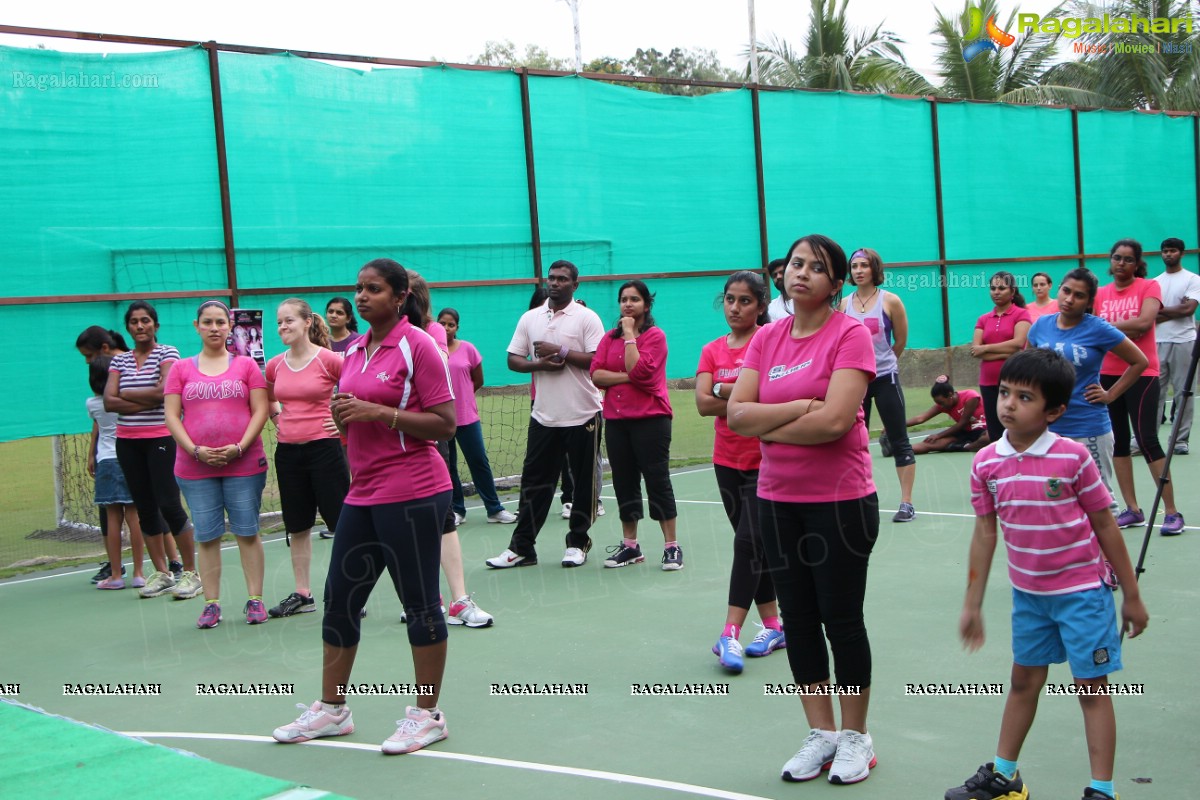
[{"x1": 971, "y1": 272, "x2": 1033, "y2": 441}]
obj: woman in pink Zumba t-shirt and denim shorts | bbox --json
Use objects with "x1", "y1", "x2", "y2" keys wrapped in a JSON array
[{"x1": 163, "y1": 300, "x2": 269, "y2": 628}]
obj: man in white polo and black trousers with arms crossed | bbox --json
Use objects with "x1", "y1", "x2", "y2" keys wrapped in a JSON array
[{"x1": 486, "y1": 261, "x2": 605, "y2": 570}]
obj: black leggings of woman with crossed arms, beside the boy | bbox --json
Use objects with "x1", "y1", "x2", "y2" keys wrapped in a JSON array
[{"x1": 758, "y1": 492, "x2": 880, "y2": 687}]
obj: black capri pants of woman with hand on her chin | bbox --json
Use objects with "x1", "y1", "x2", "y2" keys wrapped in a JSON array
[{"x1": 605, "y1": 416, "x2": 679, "y2": 522}]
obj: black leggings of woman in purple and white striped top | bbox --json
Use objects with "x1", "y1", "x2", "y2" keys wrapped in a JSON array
[{"x1": 116, "y1": 437, "x2": 187, "y2": 536}]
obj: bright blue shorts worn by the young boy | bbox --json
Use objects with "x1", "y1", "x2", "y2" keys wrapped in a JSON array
[{"x1": 1013, "y1": 587, "x2": 1121, "y2": 678}]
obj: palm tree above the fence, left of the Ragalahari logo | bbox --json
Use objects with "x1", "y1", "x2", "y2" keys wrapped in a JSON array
[{"x1": 745, "y1": 0, "x2": 934, "y2": 95}]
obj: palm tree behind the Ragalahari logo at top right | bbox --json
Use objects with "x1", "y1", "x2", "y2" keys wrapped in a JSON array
[{"x1": 1046, "y1": 0, "x2": 1200, "y2": 112}]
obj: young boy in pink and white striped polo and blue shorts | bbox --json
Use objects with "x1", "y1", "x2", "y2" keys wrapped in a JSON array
[{"x1": 946, "y1": 349, "x2": 1148, "y2": 800}]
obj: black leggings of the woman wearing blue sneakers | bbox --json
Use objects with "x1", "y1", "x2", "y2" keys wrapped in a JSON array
[{"x1": 713, "y1": 464, "x2": 775, "y2": 610}]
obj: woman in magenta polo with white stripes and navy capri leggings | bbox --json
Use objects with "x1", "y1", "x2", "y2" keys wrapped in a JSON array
[{"x1": 274, "y1": 258, "x2": 455, "y2": 753}]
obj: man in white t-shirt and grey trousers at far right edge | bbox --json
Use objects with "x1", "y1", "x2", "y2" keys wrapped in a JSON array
[{"x1": 1154, "y1": 236, "x2": 1200, "y2": 456}]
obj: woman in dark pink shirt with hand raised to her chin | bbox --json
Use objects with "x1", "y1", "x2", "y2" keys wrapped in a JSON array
[{"x1": 592, "y1": 281, "x2": 683, "y2": 570}]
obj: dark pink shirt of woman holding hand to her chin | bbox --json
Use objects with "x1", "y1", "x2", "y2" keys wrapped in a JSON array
[{"x1": 592, "y1": 326, "x2": 673, "y2": 420}]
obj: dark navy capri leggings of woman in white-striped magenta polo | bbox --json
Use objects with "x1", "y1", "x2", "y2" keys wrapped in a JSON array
[{"x1": 320, "y1": 489, "x2": 450, "y2": 648}]
